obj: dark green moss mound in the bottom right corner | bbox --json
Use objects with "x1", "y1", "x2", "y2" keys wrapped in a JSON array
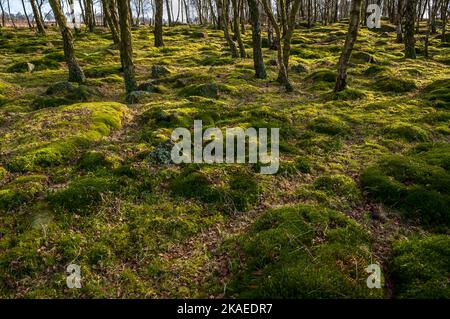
[{"x1": 391, "y1": 235, "x2": 450, "y2": 299}]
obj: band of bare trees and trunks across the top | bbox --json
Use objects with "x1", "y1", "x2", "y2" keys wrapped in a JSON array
[{"x1": 0, "y1": 0, "x2": 450, "y2": 93}]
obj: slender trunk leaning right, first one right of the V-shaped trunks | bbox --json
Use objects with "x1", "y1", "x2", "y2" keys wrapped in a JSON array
[{"x1": 334, "y1": 0, "x2": 362, "y2": 92}]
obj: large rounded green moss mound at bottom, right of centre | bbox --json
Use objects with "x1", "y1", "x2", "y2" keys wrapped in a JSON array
[{"x1": 226, "y1": 205, "x2": 382, "y2": 298}]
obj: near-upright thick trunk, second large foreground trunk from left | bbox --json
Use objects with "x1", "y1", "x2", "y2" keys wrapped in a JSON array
[{"x1": 117, "y1": 0, "x2": 137, "y2": 94}]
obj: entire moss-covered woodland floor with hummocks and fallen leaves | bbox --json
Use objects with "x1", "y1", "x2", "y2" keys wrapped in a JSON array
[{"x1": 0, "y1": 23, "x2": 450, "y2": 298}]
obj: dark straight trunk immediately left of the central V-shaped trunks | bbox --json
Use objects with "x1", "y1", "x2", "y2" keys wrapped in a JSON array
[{"x1": 248, "y1": 0, "x2": 267, "y2": 79}]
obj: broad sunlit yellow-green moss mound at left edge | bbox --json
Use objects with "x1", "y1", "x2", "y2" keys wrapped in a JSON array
[{"x1": 4, "y1": 102, "x2": 127, "y2": 172}]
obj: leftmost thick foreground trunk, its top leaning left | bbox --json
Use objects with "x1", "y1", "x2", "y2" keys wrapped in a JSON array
[{"x1": 49, "y1": 0, "x2": 85, "y2": 83}]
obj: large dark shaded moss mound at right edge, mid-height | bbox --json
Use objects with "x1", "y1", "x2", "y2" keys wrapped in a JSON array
[{"x1": 361, "y1": 145, "x2": 450, "y2": 228}]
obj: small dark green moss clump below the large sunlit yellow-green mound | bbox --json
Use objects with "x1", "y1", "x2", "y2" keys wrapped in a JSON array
[{"x1": 48, "y1": 176, "x2": 119, "y2": 214}]
